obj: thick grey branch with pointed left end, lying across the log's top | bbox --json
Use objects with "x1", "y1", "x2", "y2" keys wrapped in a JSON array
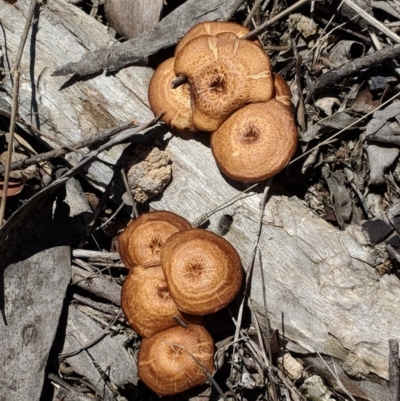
[{"x1": 54, "y1": 0, "x2": 247, "y2": 76}]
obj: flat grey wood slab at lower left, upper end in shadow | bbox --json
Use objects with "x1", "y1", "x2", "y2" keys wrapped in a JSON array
[{"x1": 0, "y1": 185, "x2": 71, "y2": 401}]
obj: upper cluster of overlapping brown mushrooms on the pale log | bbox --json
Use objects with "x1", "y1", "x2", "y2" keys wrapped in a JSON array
[{"x1": 149, "y1": 22, "x2": 298, "y2": 182}]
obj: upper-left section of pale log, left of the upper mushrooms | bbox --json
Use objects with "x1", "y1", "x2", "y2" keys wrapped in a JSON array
[{"x1": 0, "y1": 0, "x2": 152, "y2": 188}]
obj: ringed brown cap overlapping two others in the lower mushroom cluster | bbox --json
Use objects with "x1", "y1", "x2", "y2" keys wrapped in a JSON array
[{"x1": 161, "y1": 228, "x2": 243, "y2": 315}]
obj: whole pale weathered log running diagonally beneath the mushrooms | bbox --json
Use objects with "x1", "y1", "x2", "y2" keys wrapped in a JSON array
[{"x1": 0, "y1": 0, "x2": 400, "y2": 401}]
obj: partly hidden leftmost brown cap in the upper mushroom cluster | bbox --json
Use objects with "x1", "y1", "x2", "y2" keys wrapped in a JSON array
[{"x1": 148, "y1": 58, "x2": 195, "y2": 131}]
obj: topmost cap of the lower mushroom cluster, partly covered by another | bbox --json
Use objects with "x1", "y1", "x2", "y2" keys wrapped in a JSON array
[{"x1": 119, "y1": 211, "x2": 192, "y2": 269}]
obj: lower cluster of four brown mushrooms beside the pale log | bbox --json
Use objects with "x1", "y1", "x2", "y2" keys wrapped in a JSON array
[{"x1": 119, "y1": 211, "x2": 242, "y2": 395}]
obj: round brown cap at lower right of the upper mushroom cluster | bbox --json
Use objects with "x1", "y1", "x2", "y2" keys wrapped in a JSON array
[{"x1": 211, "y1": 99, "x2": 298, "y2": 182}]
